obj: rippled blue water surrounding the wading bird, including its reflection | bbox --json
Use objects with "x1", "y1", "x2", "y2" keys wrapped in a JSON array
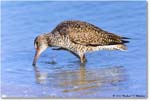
[{"x1": 1, "y1": 2, "x2": 147, "y2": 98}]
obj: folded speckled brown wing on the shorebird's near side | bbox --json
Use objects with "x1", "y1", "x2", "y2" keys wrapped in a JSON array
[{"x1": 69, "y1": 23, "x2": 123, "y2": 46}]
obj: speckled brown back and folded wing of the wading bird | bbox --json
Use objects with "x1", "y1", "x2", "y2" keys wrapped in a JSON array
[{"x1": 51, "y1": 21, "x2": 128, "y2": 46}]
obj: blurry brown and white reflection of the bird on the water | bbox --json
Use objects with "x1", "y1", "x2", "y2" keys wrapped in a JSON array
[{"x1": 34, "y1": 65, "x2": 125, "y2": 92}]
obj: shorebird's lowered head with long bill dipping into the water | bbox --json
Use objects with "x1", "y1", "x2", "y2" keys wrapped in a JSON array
[{"x1": 33, "y1": 34, "x2": 49, "y2": 65}]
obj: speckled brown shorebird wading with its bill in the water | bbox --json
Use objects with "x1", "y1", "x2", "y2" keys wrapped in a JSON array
[{"x1": 33, "y1": 20, "x2": 129, "y2": 65}]
